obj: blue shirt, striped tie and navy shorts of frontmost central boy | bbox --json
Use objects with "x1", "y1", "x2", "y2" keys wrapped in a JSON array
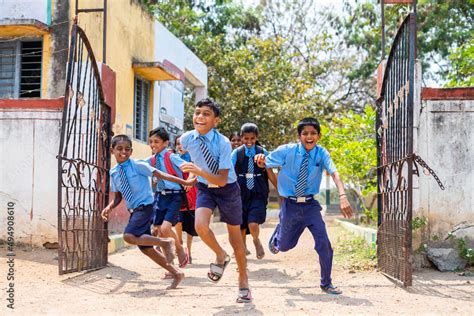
[{"x1": 181, "y1": 129, "x2": 242, "y2": 225}]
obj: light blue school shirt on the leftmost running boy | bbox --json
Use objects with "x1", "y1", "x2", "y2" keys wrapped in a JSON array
[{"x1": 110, "y1": 159, "x2": 156, "y2": 209}]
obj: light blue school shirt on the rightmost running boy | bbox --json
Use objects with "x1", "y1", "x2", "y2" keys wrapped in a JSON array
[{"x1": 266, "y1": 143, "x2": 337, "y2": 197}]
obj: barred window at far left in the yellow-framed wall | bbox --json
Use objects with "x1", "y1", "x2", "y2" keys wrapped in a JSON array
[{"x1": 0, "y1": 40, "x2": 43, "y2": 98}]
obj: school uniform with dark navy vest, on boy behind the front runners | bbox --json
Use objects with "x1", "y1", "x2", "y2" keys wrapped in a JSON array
[{"x1": 231, "y1": 145, "x2": 269, "y2": 230}]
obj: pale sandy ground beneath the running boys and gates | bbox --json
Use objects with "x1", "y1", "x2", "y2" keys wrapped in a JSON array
[{"x1": 0, "y1": 218, "x2": 474, "y2": 315}]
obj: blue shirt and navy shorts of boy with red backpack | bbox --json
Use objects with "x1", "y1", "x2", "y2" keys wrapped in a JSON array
[{"x1": 145, "y1": 148, "x2": 185, "y2": 226}]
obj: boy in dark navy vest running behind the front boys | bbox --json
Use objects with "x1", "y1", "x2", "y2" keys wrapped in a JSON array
[{"x1": 231, "y1": 123, "x2": 277, "y2": 259}]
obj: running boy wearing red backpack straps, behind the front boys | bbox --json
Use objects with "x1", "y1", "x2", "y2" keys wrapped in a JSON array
[{"x1": 145, "y1": 127, "x2": 189, "y2": 268}]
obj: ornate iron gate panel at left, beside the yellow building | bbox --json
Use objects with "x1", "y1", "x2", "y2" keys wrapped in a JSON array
[{"x1": 57, "y1": 24, "x2": 111, "y2": 274}]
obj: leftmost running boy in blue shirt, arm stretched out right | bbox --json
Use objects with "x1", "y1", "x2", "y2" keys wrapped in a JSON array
[{"x1": 101, "y1": 135, "x2": 194, "y2": 289}]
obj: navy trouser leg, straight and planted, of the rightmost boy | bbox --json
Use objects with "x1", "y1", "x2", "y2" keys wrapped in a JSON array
[{"x1": 308, "y1": 201, "x2": 333, "y2": 287}]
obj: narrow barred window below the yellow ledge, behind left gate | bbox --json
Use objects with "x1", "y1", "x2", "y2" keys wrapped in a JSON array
[{"x1": 133, "y1": 77, "x2": 150, "y2": 142}]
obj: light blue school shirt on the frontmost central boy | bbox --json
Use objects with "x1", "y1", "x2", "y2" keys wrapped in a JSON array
[{"x1": 181, "y1": 128, "x2": 237, "y2": 184}]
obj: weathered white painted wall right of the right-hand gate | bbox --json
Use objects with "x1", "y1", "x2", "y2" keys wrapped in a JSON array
[{"x1": 418, "y1": 96, "x2": 474, "y2": 238}]
